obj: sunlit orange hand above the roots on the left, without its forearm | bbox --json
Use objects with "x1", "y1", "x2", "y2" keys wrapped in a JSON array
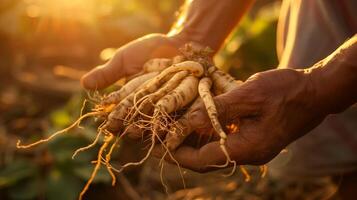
[{"x1": 81, "y1": 34, "x2": 184, "y2": 90}]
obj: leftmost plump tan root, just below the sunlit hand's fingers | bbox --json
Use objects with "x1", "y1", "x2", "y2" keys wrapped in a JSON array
[{"x1": 101, "y1": 72, "x2": 159, "y2": 105}]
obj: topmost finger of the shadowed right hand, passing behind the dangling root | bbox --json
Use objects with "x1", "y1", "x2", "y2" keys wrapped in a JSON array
[{"x1": 166, "y1": 84, "x2": 261, "y2": 150}]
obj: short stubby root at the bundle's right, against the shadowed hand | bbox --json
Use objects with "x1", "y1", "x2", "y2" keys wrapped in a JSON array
[{"x1": 210, "y1": 68, "x2": 242, "y2": 95}]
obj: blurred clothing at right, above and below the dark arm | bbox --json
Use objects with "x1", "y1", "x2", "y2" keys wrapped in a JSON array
[{"x1": 269, "y1": 0, "x2": 357, "y2": 177}]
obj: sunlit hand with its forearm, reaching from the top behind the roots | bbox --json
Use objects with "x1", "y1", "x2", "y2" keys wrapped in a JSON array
[{"x1": 81, "y1": 0, "x2": 254, "y2": 89}]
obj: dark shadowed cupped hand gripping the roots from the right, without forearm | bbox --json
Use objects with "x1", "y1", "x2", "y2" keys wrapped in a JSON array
[{"x1": 160, "y1": 69, "x2": 326, "y2": 172}]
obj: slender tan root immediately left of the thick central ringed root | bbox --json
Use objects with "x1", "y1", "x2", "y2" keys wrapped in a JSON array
[{"x1": 128, "y1": 71, "x2": 188, "y2": 122}]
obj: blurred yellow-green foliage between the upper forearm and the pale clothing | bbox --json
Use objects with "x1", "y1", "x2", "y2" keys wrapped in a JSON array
[{"x1": 215, "y1": 2, "x2": 280, "y2": 80}]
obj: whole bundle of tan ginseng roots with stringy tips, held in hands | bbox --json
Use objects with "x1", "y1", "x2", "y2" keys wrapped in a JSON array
[{"x1": 17, "y1": 44, "x2": 264, "y2": 199}]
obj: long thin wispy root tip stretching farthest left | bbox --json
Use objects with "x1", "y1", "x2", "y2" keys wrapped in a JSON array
[{"x1": 16, "y1": 112, "x2": 101, "y2": 149}]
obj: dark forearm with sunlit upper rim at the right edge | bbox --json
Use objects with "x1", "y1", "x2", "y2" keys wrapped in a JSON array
[{"x1": 307, "y1": 35, "x2": 357, "y2": 114}]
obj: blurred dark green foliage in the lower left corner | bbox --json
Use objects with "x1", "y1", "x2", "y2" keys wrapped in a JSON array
[{"x1": 0, "y1": 95, "x2": 111, "y2": 200}]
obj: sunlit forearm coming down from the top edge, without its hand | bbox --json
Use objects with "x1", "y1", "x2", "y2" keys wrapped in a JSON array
[{"x1": 169, "y1": 0, "x2": 254, "y2": 52}]
